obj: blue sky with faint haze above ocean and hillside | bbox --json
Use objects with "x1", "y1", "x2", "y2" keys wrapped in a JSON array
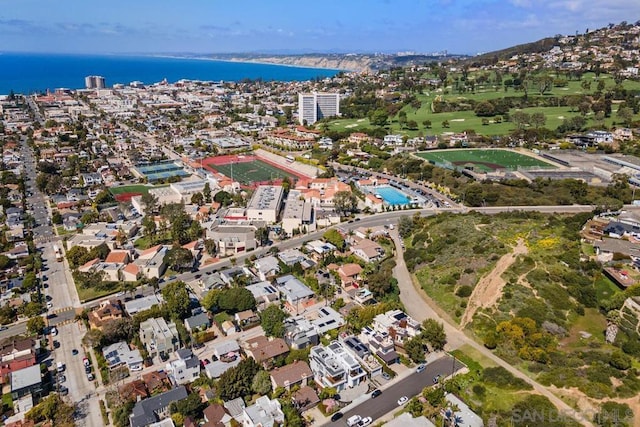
[{"x1": 0, "y1": 0, "x2": 640, "y2": 54}]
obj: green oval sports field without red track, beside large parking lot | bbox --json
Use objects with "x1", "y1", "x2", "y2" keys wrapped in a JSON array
[{"x1": 416, "y1": 149, "x2": 555, "y2": 172}]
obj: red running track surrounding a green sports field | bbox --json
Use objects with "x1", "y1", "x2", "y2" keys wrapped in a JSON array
[{"x1": 202, "y1": 154, "x2": 306, "y2": 187}]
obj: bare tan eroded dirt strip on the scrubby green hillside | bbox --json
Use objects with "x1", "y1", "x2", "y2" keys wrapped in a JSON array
[{"x1": 460, "y1": 239, "x2": 528, "y2": 329}]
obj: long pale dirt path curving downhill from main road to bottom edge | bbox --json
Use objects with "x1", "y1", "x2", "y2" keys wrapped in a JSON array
[{"x1": 391, "y1": 229, "x2": 593, "y2": 427}]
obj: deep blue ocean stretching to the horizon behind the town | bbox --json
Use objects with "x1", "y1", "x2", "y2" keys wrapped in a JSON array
[{"x1": 0, "y1": 53, "x2": 338, "y2": 94}]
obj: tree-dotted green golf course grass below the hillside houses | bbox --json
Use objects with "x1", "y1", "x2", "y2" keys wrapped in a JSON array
[{"x1": 329, "y1": 73, "x2": 640, "y2": 137}]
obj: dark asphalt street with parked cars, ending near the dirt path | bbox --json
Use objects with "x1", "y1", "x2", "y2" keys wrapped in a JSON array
[{"x1": 324, "y1": 355, "x2": 464, "y2": 427}]
